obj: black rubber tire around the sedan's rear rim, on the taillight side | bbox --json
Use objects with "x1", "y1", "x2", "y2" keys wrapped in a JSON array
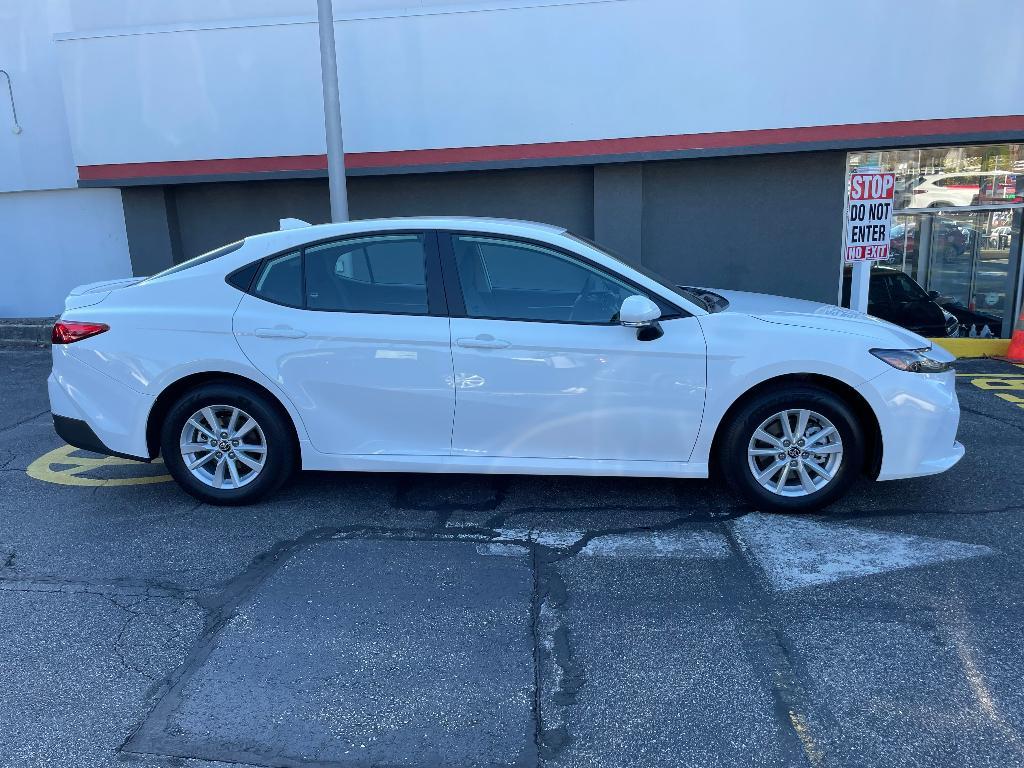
[{"x1": 160, "y1": 382, "x2": 298, "y2": 506}]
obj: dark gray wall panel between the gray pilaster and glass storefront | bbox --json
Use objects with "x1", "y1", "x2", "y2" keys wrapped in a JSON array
[{"x1": 642, "y1": 152, "x2": 846, "y2": 303}]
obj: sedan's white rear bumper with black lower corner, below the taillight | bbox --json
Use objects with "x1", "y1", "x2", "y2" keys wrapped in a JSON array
[{"x1": 47, "y1": 345, "x2": 155, "y2": 461}]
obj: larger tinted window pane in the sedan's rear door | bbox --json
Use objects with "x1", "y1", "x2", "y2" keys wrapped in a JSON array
[{"x1": 305, "y1": 233, "x2": 427, "y2": 314}]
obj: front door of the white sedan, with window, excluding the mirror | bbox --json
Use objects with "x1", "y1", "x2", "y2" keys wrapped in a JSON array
[{"x1": 441, "y1": 233, "x2": 706, "y2": 462}]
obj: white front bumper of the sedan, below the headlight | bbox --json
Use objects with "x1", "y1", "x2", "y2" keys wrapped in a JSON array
[{"x1": 857, "y1": 369, "x2": 965, "y2": 480}]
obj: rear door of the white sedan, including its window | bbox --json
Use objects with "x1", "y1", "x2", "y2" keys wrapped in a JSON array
[{"x1": 233, "y1": 231, "x2": 455, "y2": 455}]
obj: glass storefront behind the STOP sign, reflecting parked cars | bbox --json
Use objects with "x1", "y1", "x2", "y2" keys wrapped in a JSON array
[{"x1": 847, "y1": 144, "x2": 1024, "y2": 338}]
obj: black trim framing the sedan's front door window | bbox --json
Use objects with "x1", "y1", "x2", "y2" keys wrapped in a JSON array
[{"x1": 437, "y1": 229, "x2": 693, "y2": 328}]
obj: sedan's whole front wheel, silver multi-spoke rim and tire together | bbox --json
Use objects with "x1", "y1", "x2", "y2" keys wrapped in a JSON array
[{"x1": 717, "y1": 386, "x2": 864, "y2": 512}]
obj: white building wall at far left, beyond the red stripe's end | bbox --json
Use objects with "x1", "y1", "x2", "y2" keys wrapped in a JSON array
[{"x1": 0, "y1": 0, "x2": 131, "y2": 317}]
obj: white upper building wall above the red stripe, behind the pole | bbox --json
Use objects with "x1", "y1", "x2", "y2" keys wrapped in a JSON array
[{"x1": 51, "y1": 0, "x2": 1024, "y2": 166}]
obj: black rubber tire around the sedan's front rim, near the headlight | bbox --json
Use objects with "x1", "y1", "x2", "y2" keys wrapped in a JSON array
[{"x1": 716, "y1": 384, "x2": 864, "y2": 512}]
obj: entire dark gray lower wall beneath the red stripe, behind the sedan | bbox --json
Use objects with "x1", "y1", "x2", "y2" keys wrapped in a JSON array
[{"x1": 124, "y1": 152, "x2": 846, "y2": 302}]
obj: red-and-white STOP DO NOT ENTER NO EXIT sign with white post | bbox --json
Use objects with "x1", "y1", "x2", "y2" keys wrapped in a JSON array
[{"x1": 843, "y1": 173, "x2": 896, "y2": 312}]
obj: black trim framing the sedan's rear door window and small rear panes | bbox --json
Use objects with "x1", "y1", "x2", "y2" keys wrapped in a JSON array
[{"x1": 237, "y1": 229, "x2": 449, "y2": 317}]
